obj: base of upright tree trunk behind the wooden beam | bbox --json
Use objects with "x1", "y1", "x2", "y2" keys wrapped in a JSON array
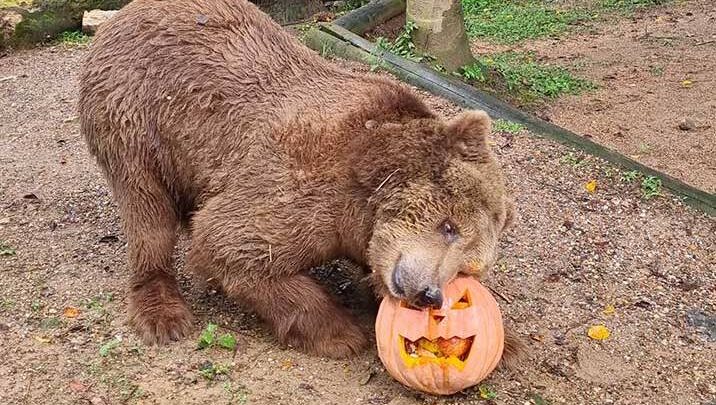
[{"x1": 406, "y1": 0, "x2": 475, "y2": 72}]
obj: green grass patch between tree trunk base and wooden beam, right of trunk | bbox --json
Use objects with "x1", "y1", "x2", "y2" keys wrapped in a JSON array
[{"x1": 460, "y1": 52, "x2": 596, "y2": 105}]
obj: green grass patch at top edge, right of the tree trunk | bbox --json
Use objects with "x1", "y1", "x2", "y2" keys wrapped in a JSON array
[{"x1": 462, "y1": 0, "x2": 592, "y2": 44}]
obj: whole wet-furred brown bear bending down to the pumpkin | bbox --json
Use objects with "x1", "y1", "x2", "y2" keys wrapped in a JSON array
[{"x1": 79, "y1": 0, "x2": 512, "y2": 357}]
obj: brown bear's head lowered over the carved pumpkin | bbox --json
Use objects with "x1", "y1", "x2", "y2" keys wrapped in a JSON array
[{"x1": 355, "y1": 111, "x2": 513, "y2": 307}]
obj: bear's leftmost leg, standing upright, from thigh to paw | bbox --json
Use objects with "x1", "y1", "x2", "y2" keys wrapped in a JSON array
[{"x1": 114, "y1": 172, "x2": 192, "y2": 344}]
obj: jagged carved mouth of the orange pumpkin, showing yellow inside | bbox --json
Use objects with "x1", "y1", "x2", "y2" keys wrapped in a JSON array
[{"x1": 399, "y1": 336, "x2": 475, "y2": 370}]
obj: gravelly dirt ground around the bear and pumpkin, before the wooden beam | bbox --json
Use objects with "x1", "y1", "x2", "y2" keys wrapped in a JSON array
[{"x1": 0, "y1": 36, "x2": 716, "y2": 405}]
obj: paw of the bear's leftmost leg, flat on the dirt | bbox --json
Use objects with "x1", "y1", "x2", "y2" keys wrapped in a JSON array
[{"x1": 129, "y1": 281, "x2": 192, "y2": 345}]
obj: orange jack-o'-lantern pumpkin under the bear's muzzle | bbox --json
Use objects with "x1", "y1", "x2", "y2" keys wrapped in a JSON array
[{"x1": 375, "y1": 276, "x2": 504, "y2": 395}]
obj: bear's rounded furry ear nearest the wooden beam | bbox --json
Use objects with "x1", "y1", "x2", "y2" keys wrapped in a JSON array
[{"x1": 447, "y1": 110, "x2": 492, "y2": 161}]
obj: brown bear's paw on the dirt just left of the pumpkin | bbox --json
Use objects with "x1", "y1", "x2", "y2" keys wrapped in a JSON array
[{"x1": 278, "y1": 309, "x2": 368, "y2": 359}]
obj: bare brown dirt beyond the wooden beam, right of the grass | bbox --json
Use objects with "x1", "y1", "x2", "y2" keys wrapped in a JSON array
[{"x1": 473, "y1": 0, "x2": 716, "y2": 193}]
